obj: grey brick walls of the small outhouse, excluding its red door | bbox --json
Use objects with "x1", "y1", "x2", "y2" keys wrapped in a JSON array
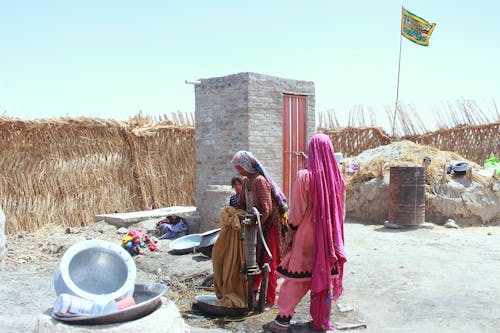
[{"x1": 195, "y1": 73, "x2": 315, "y2": 231}]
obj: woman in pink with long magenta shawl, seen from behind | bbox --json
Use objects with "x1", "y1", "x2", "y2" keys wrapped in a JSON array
[{"x1": 263, "y1": 134, "x2": 346, "y2": 332}]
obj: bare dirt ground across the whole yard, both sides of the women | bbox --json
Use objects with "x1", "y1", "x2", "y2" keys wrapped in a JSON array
[{"x1": 0, "y1": 221, "x2": 500, "y2": 333}]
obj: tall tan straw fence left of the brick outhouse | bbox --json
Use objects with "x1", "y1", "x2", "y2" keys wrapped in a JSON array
[{"x1": 0, "y1": 118, "x2": 194, "y2": 233}]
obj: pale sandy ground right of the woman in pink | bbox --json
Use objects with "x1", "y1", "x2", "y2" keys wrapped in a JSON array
[{"x1": 344, "y1": 220, "x2": 500, "y2": 333}]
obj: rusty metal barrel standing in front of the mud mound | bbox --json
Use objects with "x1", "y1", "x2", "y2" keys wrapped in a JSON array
[{"x1": 389, "y1": 166, "x2": 425, "y2": 227}]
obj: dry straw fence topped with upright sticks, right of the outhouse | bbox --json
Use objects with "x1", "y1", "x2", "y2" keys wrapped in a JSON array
[{"x1": 318, "y1": 100, "x2": 500, "y2": 165}]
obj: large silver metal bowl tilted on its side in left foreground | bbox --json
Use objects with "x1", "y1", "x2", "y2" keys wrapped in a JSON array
[{"x1": 54, "y1": 239, "x2": 136, "y2": 301}]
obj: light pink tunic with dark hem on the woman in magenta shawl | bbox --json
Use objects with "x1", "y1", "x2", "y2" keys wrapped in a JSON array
[{"x1": 278, "y1": 170, "x2": 314, "y2": 281}]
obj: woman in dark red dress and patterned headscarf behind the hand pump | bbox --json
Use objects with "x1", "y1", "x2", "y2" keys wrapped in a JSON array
[{"x1": 231, "y1": 150, "x2": 288, "y2": 310}]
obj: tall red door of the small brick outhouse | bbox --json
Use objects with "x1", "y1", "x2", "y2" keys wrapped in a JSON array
[{"x1": 283, "y1": 94, "x2": 307, "y2": 201}]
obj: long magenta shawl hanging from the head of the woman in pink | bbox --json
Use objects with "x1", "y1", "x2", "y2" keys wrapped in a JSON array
[{"x1": 307, "y1": 134, "x2": 346, "y2": 330}]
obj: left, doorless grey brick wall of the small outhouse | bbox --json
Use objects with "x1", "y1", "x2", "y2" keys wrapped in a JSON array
[{"x1": 195, "y1": 74, "x2": 249, "y2": 188}]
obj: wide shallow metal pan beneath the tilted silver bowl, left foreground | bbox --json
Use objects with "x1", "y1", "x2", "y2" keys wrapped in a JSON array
[{"x1": 51, "y1": 283, "x2": 167, "y2": 325}]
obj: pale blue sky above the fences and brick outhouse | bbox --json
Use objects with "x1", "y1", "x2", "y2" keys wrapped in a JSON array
[{"x1": 0, "y1": 0, "x2": 500, "y2": 130}]
